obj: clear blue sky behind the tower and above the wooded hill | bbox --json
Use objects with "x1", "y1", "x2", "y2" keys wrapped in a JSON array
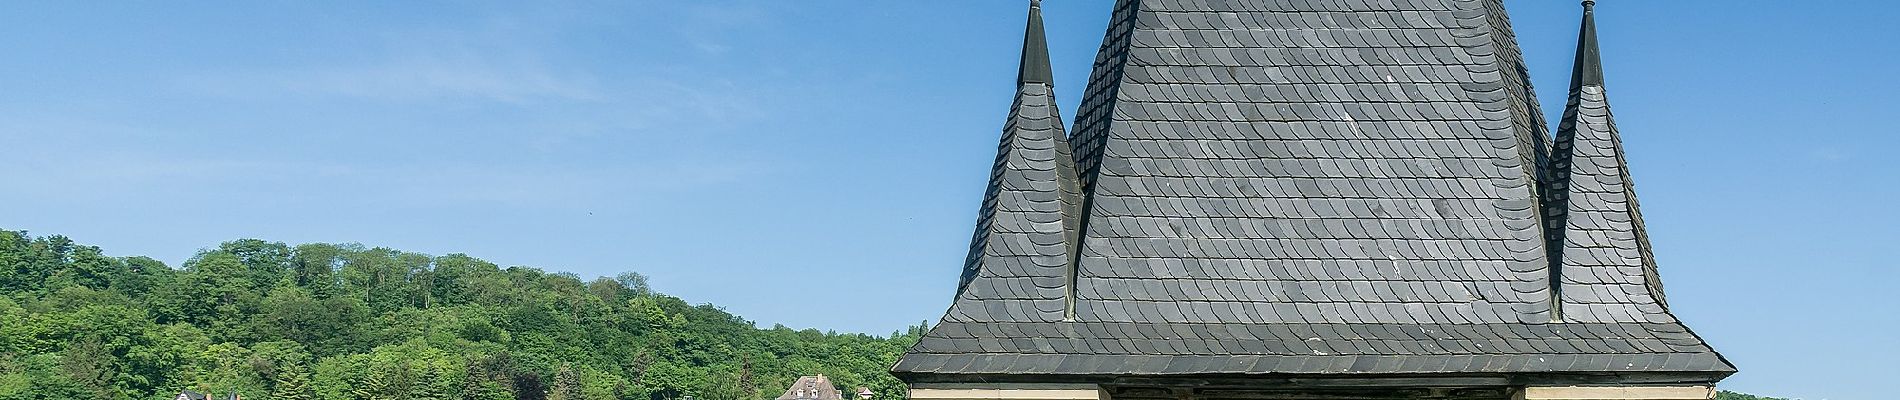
[{"x1": 0, "y1": 0, "x2": 1900, "y2": 398}]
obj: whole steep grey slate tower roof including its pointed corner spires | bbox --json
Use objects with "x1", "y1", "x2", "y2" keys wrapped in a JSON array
[{"x1": 893, "y1": 0, "x2": 1735, "y2": 383}]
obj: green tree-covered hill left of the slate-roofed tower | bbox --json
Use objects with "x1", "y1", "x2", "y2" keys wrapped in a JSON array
[{"x1": 0, "y1": 231, "x2": 922, "y2": 400}]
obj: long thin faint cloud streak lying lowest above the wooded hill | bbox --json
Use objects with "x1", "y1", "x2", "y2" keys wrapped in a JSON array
[{"x1": 0, "y1": 146, "x2": 766, "y2": 209}]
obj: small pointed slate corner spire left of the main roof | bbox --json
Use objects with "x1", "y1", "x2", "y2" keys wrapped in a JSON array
[{"x1": 944, "y1": 2, "x2": 1081, "y2": 322}]
